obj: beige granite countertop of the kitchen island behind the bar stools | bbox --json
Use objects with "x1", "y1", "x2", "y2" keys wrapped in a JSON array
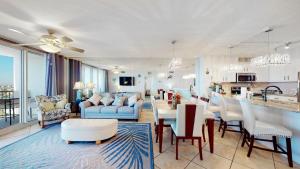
[{"x1": 224, "y1": 95, "x2": 300, "y2": 113}]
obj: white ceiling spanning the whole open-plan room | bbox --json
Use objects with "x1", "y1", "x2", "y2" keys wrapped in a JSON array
[{"x1": 0, "y1": 0, "x2": 300, "y2": 68}]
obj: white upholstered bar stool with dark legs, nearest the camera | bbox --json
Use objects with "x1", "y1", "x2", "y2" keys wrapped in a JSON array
[{"x1": 240, "y1": 99, "x2": 293, "y2": 167}]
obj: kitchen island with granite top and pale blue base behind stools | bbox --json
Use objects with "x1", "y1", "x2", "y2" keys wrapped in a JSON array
[{"x1": 218, "y1": 95, "x2": 300, "y2": 163}]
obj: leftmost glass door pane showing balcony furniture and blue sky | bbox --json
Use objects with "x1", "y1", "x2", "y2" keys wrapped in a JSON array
[{"x1": 0, "y1": 45, "x2": 21, "y2": 129}]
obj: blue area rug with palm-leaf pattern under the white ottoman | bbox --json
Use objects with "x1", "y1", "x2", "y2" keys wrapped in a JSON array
[{"x1": 0, "y1": 123, "x2": 154, "y2": 169}]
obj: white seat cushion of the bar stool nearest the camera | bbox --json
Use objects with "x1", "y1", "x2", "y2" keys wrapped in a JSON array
[{"x1": 254, "y1": 120, "x2": 292, "y2": 137}]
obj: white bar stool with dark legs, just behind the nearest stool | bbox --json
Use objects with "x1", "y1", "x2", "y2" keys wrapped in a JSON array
[{"x1": 215, "y1": 93, "x2": 243, "y2": 138}]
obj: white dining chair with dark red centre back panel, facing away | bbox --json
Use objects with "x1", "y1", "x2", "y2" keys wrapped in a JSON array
[{"x1": 171, "y1": 104, "x2": 204, "y2": 160}]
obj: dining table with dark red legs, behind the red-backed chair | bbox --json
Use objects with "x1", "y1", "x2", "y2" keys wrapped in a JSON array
[{"x1": 156, "y1": 100, "x2": 215, "y2": 153}]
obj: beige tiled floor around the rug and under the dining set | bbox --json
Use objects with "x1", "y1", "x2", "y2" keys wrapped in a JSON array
[{"x1": 0, "y1": 110, "x2": 300, "y2": 169}]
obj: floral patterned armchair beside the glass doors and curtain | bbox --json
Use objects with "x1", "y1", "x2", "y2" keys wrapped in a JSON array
[{"x1": 35, "y1": 94, "x2": 71, "y2": 128}]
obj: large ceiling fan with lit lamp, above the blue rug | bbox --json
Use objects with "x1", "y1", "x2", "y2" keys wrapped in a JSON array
[{"x1": 15, "y1": 29, "x2": 84, "y2": 53}]
